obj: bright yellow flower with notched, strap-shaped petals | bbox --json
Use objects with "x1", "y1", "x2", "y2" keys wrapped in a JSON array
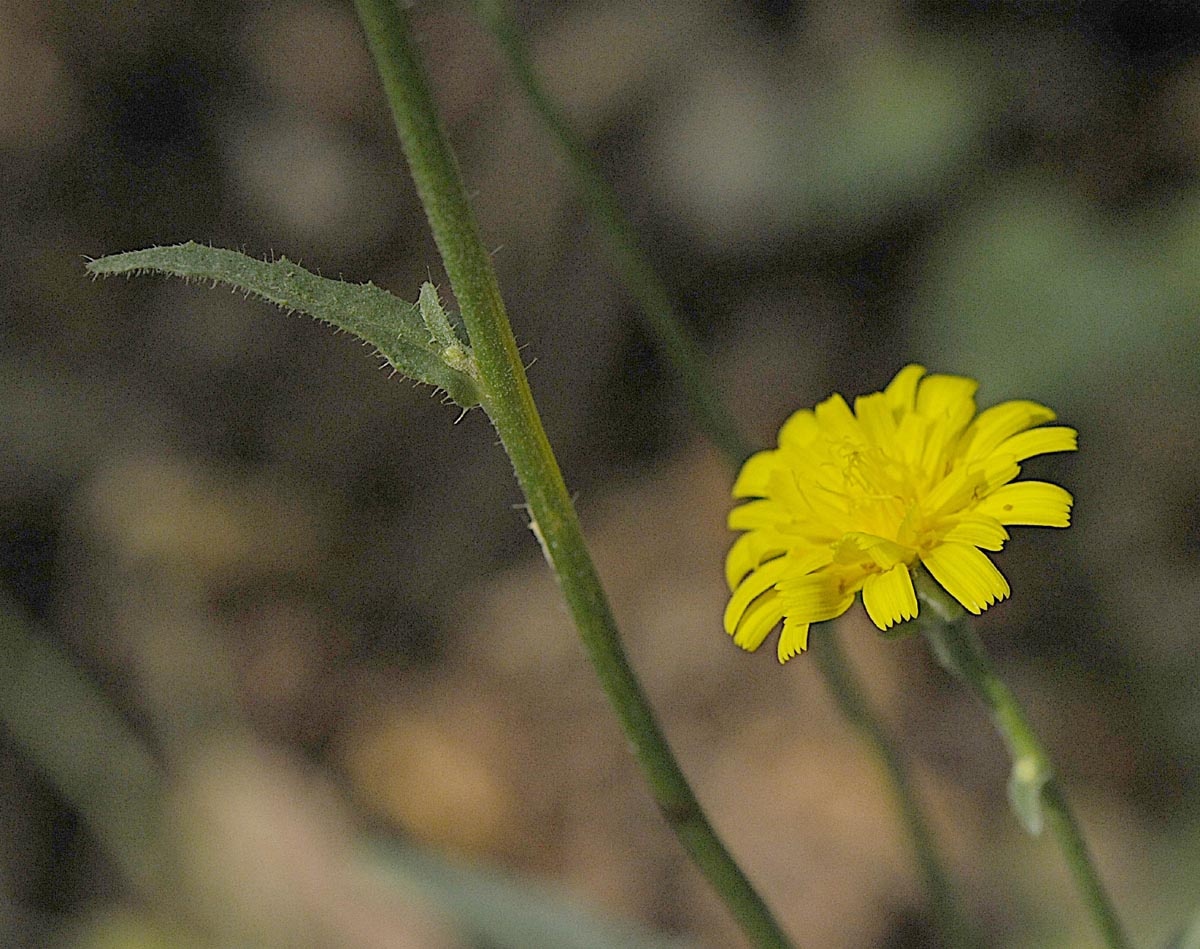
[{"x1": 725, "y1": 366, "x2": 1076, "y2": 662}]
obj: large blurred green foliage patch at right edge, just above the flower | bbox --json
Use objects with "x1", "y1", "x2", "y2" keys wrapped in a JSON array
[{"x1": 916, "y1": 173, "x2": 1200, "y2": 408}]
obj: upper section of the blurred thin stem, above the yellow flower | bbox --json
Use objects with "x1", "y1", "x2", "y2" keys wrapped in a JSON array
[{"x1": 475, "y1": 0, "x2": 752, "y2": 466}]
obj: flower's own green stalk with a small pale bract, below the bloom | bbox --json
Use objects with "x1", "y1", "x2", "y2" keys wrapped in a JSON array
[{"x1": 916, "y1": 570, "x2": 1129, "y2": 949}]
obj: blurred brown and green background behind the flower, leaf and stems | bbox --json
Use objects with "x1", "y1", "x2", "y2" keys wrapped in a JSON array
[{"x1": 0, "y1": 0, "x2": 1200, "y2": 949}]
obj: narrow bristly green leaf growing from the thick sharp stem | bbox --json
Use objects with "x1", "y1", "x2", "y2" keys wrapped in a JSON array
[{"x1": 88, "y1": 241, "x2": 479, "y2": 408}]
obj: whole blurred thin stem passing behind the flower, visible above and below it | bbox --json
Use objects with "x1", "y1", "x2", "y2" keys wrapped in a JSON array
[{"x1": 474, "y1": 0, "x2": 977, "y2": 945}]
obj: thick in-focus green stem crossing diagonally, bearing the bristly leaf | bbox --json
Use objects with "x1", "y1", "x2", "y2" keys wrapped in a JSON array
[{"x1": 355, "y1": 0, "x2": 791, "y2": 947}]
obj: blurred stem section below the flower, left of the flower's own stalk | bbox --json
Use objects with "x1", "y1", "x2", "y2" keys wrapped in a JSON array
[{"x1": 812, "y1": 623, "x2": 982, "y2": 947}]
